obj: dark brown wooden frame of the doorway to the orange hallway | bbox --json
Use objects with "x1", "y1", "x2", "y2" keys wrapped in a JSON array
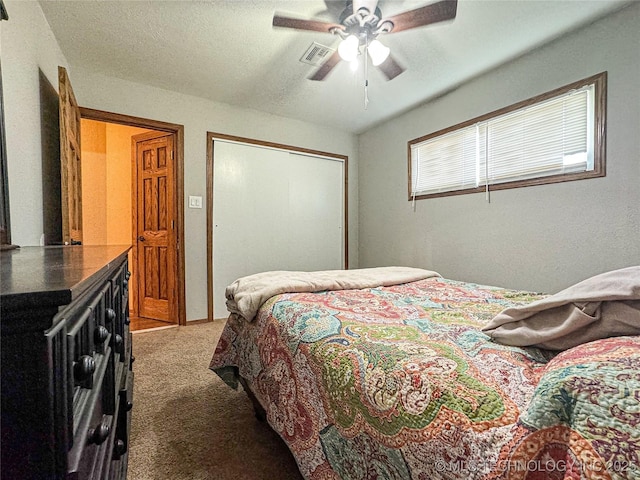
[{"x1": 80, "y1": 107, "x2": 187, "y2": 325}]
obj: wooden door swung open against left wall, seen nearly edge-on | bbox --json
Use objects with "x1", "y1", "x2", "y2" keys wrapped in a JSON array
[{"x1": 58, "y1": 67, "x2": 82, "y2": 245}]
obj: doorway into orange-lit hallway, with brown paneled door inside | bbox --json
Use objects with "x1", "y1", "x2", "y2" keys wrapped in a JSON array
[{"x1": 80, "y1": 108, "x2": 186, "y2": 331}]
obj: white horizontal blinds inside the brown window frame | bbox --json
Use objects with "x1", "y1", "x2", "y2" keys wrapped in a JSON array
[{"x1": 411, "y1": 84, "x2": 594, "y2": 196}]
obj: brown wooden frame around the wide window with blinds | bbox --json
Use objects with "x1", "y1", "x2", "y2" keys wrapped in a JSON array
[{"x1": 407, "y1": 71, "x2": 607, "y2": 201}]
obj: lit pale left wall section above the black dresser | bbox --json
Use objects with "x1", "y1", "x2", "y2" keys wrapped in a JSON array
[{"x1": 0, "y1": 1, "x2": 67, "y2": 245}]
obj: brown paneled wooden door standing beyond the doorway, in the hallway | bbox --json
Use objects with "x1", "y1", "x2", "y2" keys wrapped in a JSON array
[{"x1": 132, "y1": 132, "x2": 178, "y2": 323}]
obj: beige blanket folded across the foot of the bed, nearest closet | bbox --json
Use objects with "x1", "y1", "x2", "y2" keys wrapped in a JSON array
[{"x1": 225, "y1": 267, "x2": 440, "y2": 321}]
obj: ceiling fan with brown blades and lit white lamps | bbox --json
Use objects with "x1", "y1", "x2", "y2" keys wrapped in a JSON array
[{"x1": 273, "y1": 0, "x2": 458, "y2": 80}]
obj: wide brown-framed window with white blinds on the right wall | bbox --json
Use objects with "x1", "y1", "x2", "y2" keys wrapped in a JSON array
[{"x1": 408, "y1": 72, "x2": 607, "y2": 200}]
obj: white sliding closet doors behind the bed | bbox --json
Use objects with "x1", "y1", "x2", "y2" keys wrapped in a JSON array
[{"x1": 213, "y1": 140, "x2": 344, "y2": 318}]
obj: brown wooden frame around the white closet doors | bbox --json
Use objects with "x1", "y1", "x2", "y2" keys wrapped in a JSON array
[{"x1": 206, "y1": 132, "x2": 349, "y2": 322}]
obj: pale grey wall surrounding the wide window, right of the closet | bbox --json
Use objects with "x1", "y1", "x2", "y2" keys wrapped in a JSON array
[{"x1": 359, "y1": 3, "x2": 640, "y2": 292}]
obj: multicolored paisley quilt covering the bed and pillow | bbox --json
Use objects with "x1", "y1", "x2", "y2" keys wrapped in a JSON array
[{"x1": 210, "y1": 268, "x2": 640, "y2": 480}]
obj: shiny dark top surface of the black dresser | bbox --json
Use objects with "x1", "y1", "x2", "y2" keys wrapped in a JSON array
[{"x1": 0, "y1": 245, "x2": 130, "y2": 310}]
